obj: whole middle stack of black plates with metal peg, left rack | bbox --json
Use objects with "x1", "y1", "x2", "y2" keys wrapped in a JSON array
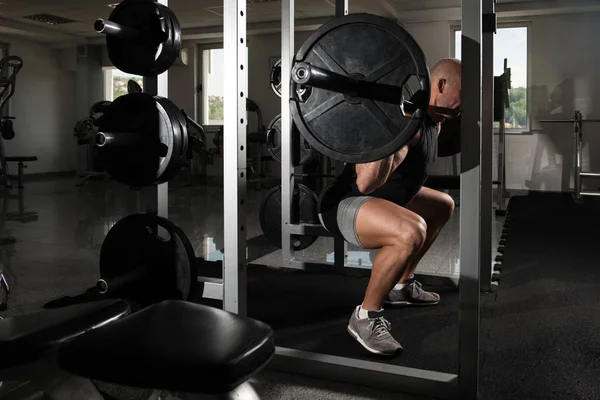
[{"x1": 96, "y1": 93, "x2": 189, "y2": 187}]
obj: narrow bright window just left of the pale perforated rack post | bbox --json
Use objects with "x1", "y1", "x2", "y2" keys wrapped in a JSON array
[{"x1": 200, "y1": 49, "x2": 225, "y2": 125}]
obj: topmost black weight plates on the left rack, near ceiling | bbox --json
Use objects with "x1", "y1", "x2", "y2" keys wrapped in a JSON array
[{"x1": 106, "y1": 0, "x2": 181, "y2": 76}]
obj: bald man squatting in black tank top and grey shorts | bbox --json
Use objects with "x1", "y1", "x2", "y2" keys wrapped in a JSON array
[{"x1": 319, "y1": 58, "x2": 461, "y2": 356}]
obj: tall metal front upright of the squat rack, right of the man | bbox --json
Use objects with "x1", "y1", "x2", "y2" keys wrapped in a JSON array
[{"x1": 458, "y1": 0, "x2": 482, "y2": 400}]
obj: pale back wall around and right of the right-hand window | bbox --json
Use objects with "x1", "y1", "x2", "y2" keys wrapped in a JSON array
[{"x1": 406, "y1": 13, "x2": 600, "y2": 191}]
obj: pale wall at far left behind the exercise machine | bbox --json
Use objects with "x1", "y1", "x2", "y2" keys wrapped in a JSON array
[{"x1": 0, "y1": 37, "x2": 77, "y2": 173}]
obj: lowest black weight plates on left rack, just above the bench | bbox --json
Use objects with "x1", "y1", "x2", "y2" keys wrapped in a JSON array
[{"x1": 100, "y1": 214, "x2": 196, "y2": 307}]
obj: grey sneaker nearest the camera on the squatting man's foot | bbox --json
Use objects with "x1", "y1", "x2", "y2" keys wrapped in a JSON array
[{"x1": 348, "y1": 306, "x2": 404, "y2": 356}]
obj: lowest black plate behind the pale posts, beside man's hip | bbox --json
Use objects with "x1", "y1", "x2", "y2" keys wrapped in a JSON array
[{"x1": 259, "y1": 184, "x2": 319, "y2": 251}]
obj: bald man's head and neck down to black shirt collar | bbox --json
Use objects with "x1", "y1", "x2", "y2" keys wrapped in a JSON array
[{"x1": 429, "y1": 58, "x2": 462, "y2": 122}]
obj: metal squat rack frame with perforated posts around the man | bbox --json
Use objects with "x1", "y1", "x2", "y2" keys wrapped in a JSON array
[{"x1": 191, "y1": 0, "x2": 495, "y2": 400}]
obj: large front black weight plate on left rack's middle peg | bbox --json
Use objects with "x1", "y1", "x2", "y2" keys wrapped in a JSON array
[{"x1": 98, "y1": 93, "x2": 175, "y2": 187}]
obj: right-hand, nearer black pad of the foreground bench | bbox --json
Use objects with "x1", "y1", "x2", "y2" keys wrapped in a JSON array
[{"x1": 58, "y1": 300, "x2": 275, "y2": 394}]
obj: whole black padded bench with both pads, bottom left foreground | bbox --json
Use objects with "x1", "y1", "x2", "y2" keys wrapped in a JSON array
[{"x1": 0, "y1": 300, "x2": 275, "y2": 400}]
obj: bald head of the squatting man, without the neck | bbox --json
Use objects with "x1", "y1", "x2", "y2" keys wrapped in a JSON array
[{"x1": 429, "y1": 58, "x2": 462, "y2": 120}]
